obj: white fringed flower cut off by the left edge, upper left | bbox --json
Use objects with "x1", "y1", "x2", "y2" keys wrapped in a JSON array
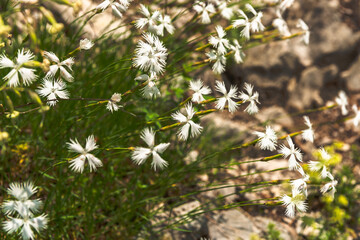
[{"x1": 0, "y1": 49, "x2": 37, "y2": 87}]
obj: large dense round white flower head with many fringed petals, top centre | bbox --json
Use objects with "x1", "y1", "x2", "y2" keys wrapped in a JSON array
[{"x1": 134, "y1": 33, "x2": 168, "y2": 74}]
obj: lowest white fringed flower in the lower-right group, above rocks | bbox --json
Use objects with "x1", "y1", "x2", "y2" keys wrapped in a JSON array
[{"x1": 280, "y1": 191, "x2": 307, "y2": 218}]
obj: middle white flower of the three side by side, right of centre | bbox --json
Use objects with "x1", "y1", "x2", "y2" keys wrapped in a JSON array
[{"x1": 215, "y1": 81, "x2": 239, "y2": 113}]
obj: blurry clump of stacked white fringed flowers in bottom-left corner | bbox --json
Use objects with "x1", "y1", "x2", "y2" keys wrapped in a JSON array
[{"x1": 1, "y1": 182, "x2": 48, "y2": 240}]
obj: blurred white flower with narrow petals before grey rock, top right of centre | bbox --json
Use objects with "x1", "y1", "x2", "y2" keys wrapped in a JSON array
[{"x1": 233, "y1": 3, "x2": 265, "y2": 39}]
